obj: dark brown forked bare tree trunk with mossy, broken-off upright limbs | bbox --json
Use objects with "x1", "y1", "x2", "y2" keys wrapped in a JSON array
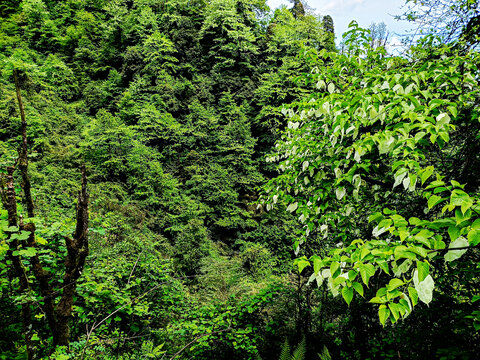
[{"x1": 5, "y1": 70, "x2": 88, "y2": 348}]
